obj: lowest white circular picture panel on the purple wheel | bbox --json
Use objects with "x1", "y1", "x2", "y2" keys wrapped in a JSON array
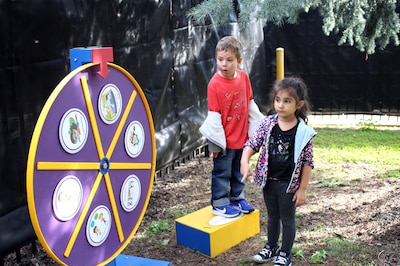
[{"x1": 86, "y1": 205, "x2": 111, "y2": 247}]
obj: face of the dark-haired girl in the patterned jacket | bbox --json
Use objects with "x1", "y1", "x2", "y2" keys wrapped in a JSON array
[{"x1": 274, "y1": 89, "x2": 304, "y2": 119}]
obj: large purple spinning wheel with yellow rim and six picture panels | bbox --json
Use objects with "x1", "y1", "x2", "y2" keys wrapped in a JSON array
[{"x1": 26, "y1": 57, "x2": 156, "y2": 265}]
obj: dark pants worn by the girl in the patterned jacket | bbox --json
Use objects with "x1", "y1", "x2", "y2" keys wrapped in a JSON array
[{"x1": 263, "y1": 180, "x2": 296, "y2": 254}]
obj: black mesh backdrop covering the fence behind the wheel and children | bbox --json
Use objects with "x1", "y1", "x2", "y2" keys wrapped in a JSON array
[{"x1": 0, "y1": 0, "x2": 400, "y2": 216}]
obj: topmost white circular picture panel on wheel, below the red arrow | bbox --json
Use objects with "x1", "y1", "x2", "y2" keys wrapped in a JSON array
[{"x1": 98, "y1": 84, "x2": 122, "y2": 124}]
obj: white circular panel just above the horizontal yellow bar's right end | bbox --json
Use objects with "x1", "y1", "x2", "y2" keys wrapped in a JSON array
[{"x1": 125, "y1": 121, "x2": 145, "y2": 158}]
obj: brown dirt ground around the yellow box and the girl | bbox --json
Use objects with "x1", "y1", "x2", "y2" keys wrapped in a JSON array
[{"x1": 5, "y1": 155, "x2": 400, "y2": 266}]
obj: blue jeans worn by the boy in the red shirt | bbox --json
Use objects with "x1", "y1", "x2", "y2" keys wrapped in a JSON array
[{"x1": 211, "y1": 149, "x2": 245, "y2": 207}]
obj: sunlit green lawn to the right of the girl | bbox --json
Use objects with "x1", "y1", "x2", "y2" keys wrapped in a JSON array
[{"x1": 313, "y1": 128, "x2": 400, "y2": 187}]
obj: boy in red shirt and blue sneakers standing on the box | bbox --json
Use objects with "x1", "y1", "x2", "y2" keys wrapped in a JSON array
[{"x1": 200, "y1": 36, "x2": 264, "y2": 218}]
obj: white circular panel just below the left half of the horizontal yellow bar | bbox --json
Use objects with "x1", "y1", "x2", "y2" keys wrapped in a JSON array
[{"x1": 53, "y1": 175, "x2": 83, "y2": 221}]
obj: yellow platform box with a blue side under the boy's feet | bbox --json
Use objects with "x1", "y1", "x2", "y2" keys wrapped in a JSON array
[{"x1": 175, "y1": 206, "x2": 260, "y2": 258}]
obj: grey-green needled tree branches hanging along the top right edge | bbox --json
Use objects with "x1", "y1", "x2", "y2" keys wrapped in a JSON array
[{"x1": 187, "y1": 0, "x2": 400, "y2": 57}]
